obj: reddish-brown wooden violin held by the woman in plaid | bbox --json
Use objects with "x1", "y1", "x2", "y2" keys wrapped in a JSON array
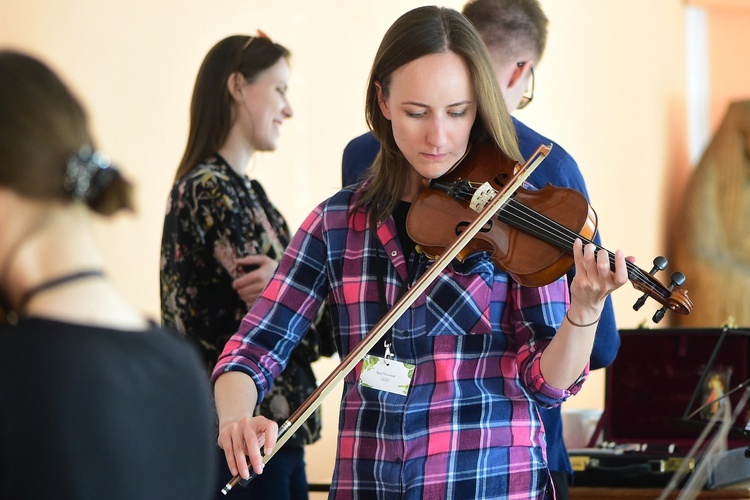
[{"x1": 406, "y1": 144, "x2": 693, "y2": 323}]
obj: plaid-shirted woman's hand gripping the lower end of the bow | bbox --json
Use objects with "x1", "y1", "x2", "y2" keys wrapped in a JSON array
[{"x1": 218, "y1": 416, "x2": 279, "y2": 479}]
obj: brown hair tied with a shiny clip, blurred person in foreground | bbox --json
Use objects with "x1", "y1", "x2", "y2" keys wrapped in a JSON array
[{"x1": 0, "y1": 50, "x2": 132, "y2": 215}]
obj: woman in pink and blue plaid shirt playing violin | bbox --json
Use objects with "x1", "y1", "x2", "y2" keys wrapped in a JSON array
[{"x1": 214, "y1": 7, "x2": 627, "y2": 499}]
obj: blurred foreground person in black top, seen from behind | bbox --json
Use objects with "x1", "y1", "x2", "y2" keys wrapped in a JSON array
[{"x1": 0, "y1": 50, "x2": 215, "y2": 500}]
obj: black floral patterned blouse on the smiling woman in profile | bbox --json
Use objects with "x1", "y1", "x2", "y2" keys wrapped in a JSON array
[{"x1": 160, "y1": 155, "x2": 335, "y2": 446}]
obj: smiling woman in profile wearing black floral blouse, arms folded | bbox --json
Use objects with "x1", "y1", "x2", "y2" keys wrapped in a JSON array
[{"x1": 160, "y1": 32, "x2": 335, "y2": 500}]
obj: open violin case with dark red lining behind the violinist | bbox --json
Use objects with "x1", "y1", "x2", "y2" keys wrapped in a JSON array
[{"x1": 569, "y1": 328, "x2": 750, "y2": 489}]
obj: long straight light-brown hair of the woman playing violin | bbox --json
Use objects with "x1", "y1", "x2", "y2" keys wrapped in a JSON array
[{"x1": 353, "y1": 7, "x2": 522, "y2": 228}]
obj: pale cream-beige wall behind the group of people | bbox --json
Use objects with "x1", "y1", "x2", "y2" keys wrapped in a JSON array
[{"x1": 0, "y1": 0, "x2": 704, "y2": 488}]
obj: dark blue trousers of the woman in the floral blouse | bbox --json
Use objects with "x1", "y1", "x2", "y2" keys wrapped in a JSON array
[{"x1": 216, "y1": 446, "x2": 309, "y2": 500}]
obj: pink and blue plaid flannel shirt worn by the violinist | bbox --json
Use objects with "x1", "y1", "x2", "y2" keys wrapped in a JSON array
[{"x1": 214, "y1": 189, "x2": 588, "y2": 499}]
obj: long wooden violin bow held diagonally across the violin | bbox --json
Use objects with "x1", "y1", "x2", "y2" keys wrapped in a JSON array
[{"x1": 221, "y1": 145, "x2": 552, "y2": 495}]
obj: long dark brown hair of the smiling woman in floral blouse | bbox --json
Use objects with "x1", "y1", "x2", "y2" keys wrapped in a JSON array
[{"x1": 175, "y1": 32, "x2": 291, "y2": 180}]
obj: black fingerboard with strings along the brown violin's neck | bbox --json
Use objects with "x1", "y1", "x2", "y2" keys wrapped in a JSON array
[{"x1": 460, "y1": 183, "x2": 670, "y2": 298}]
